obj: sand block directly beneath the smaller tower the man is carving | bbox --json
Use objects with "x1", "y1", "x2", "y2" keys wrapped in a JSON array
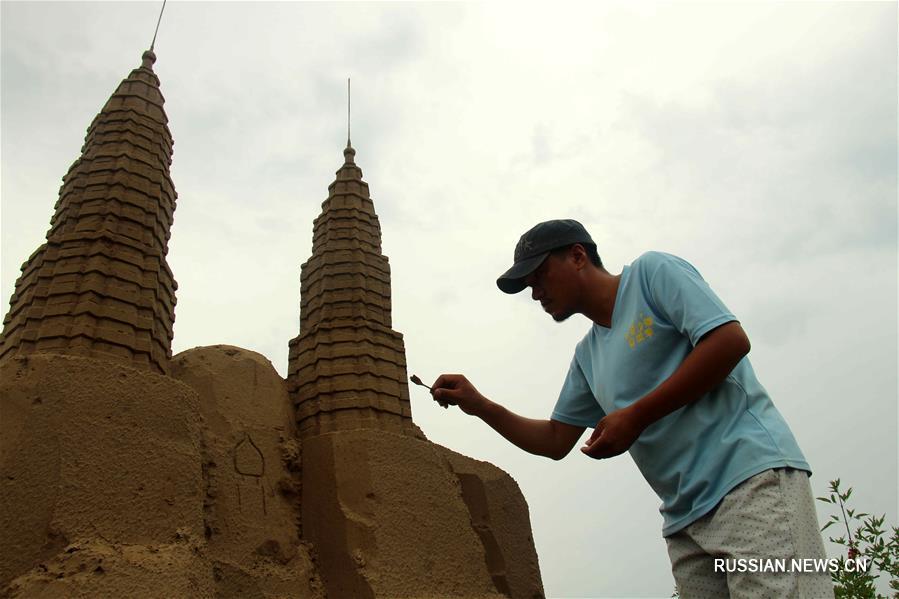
[{"x1": 302, "y1": 430, "x2": 503, "y2": 599}]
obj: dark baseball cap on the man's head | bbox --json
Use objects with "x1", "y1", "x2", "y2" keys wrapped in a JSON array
[{"x1": 496, "y1": 219, "x2": 596, "y2": 293}]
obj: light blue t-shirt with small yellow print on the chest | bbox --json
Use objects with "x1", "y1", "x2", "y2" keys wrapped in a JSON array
[{"x1": 552, "y1": 252, "x2": 811, "y2": 536}]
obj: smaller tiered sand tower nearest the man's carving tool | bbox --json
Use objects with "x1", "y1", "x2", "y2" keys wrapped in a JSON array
[{"x1": 287, "y1": 140, "x2": 412, "y2": 437}]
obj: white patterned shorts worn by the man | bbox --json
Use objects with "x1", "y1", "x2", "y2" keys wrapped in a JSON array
[{"x1": 665, "y1": 468, "x2": 833, "y2": 599}]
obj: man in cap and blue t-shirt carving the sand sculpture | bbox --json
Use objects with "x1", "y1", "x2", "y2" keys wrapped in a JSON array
[{"x1": 432, "y1": 220, "x2": 833, "y2": 598}]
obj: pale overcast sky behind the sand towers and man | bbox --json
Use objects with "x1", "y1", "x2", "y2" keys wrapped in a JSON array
[{"x1": 0, "y1": 1, "x2": 899, "y2": 597}]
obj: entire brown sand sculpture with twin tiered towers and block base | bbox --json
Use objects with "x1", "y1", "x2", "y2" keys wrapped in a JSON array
[{"x1": 0, "y1": 51, "x2": 543, "y2": 599}]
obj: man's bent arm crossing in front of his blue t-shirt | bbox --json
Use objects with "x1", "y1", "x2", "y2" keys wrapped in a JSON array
[{"x1": 581, "y1": 321, "x2": 750, "y2": 459}]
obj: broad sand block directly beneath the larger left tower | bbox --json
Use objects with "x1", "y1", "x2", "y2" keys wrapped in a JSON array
[{"x1": 0, "y1": 354, "x2": 204, "y2": 586}]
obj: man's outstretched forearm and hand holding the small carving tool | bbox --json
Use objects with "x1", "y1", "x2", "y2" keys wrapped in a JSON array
[{"x1": 431, "y1": 374, "x2": 585, "y2": 460}]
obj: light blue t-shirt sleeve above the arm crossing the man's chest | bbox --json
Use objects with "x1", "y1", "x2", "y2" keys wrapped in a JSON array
[{"x1": 648, "y1": 252, "x2": 736, "y2": 346}]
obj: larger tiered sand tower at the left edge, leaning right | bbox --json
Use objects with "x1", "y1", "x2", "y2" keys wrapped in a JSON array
[{"x1": 0, "y1": 50, "x2": 177, "y2": 374}]
